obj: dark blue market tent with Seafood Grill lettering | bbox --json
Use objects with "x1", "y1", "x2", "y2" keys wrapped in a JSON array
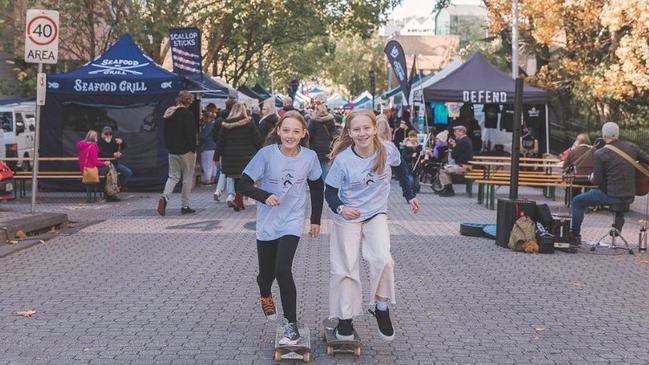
[{"x1": 40, "y1": 34, "x2": 184, "y2": 190}]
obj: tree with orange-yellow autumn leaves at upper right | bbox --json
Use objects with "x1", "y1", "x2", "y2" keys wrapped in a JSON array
[{"x1": 486, "y1": 0, "x2": 649, "y2": 119}]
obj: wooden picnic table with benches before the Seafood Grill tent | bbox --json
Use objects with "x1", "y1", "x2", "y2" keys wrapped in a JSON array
[{"x1": 4, "y1": 157, "x2": 114, "y2": 200}]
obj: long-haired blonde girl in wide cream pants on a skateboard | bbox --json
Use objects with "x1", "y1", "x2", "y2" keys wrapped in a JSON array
[{"x1": 325, "y1": 111, "x2": 420, "y2": 341}]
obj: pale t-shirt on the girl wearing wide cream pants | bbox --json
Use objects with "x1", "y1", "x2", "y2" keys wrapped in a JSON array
[{"x1": 325, "y1": 142, "x2": 401, "y2": 223}]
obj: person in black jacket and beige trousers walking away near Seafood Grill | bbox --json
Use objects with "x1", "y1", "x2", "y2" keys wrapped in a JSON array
[{"x1": 158, "y1": 90, "x2": 196, "y2": 215}]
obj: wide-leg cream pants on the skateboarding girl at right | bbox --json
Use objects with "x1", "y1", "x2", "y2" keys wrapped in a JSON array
[{"x1": 329, "y1": 214, "x2": 395, "y2": 319}]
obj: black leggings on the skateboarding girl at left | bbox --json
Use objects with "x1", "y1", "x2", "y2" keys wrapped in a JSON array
[{"x1": 257, "y1": 235, "x2": 300, "y2": 323}]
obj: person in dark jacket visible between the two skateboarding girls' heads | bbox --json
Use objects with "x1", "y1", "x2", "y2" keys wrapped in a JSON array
[{"x1": 309, "y1": 104, "x2": 336, "y2": 179}]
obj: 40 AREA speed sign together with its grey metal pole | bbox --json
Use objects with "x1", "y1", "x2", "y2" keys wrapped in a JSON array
[{"x1": 25, "y1": 9, "x2": 59, "y2": 214}]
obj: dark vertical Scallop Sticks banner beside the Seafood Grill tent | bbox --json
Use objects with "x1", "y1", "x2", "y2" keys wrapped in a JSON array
[{"x1": 169, "y1": 28, "x2": 203, "y2": 79}]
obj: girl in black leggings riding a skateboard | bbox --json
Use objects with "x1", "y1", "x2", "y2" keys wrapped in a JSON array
[{"x1": 237, "y1": 111, "x2": 324, "y2": 345}]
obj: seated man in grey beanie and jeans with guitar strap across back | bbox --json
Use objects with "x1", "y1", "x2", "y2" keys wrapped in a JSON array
[{"x1": 570, "y1": 122, "x2": 649, "y2": 245}]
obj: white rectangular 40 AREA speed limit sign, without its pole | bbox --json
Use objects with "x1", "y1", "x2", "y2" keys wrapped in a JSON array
[{"x1": 25, "y1": 9, "x2": 59, "y2": 63}]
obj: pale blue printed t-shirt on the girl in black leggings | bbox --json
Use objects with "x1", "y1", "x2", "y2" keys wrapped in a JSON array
[{"x1": 243, "y1": 144, "x2": 322, "y2": 241}]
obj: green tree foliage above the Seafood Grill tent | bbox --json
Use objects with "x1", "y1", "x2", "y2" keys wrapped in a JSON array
[{"x1": 0, "y1": 0, "x2": 400, "y2": 96}]
